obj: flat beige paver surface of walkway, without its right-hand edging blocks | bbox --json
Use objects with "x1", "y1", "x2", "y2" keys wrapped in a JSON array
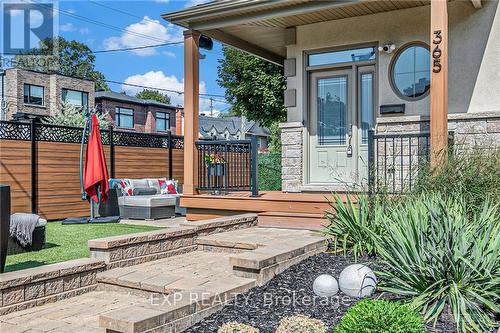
[{"x1": 0, "y1": 227, "x2": 326, "y2": 333}]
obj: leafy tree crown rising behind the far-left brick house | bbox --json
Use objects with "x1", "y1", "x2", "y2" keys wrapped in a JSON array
[{"x1": 14, "y1": 37, "x2": 109, "y2": 90}]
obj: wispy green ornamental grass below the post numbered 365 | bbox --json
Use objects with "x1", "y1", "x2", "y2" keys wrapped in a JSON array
[{"x1": 413, "y1": 146, "x2": 500, "y2": 212}]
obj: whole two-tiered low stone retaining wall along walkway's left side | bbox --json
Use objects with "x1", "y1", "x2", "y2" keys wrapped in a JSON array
[{"x1": 0, "y1": 214, "x2": 257, "y2": 316}]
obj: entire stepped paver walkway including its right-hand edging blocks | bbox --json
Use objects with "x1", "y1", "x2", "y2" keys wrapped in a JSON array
[{"x1": 0, "y1": 227, "x2": 325, "y2": 333}]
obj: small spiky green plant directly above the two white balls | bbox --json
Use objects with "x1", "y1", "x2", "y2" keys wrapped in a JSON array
[{"x1": 323, "y1": 194, "x2": 383, "y2": 260}]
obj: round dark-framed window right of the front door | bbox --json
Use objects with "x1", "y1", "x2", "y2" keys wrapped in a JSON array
[{"x1": 390, "y1": 43, "x2": 431, "y2": 101}]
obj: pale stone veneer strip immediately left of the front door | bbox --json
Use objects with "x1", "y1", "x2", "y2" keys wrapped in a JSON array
[{"x1": 280, "y1": 122, "x2": 303, "y2": 192}]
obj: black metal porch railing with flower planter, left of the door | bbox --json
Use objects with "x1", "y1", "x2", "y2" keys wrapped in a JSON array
[{"x1": 196, "y1": 137, "x2": 259, "y2": 196}]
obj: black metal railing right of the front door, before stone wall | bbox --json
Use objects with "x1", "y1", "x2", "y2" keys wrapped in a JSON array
[{"x1": 368, "y1": 130, "x2": 454, "y2": 193}]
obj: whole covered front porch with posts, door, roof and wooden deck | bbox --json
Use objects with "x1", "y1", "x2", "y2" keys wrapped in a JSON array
[{"x1": 163, "y1": 0, "x2": 488, "y2": 223}]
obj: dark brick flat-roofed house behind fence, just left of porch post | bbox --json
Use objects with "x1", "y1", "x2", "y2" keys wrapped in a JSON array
[{"x1": 95, "y1": 91, "x2": 182, "y2": 133}]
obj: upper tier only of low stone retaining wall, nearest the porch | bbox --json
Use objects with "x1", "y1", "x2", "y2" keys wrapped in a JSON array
[{"x1": 88, "y1": 214, "x2": 257, "y2": 269}]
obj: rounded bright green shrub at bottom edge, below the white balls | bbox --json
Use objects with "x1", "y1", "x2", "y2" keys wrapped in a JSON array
[{"x1": 334, "y1": 300, "x2": 425, "y2": 333}]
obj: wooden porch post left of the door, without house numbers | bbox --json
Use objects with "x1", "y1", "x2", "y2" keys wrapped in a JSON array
[{"x1": 183, "y1": 30, "x2": 200, "y2": 195}]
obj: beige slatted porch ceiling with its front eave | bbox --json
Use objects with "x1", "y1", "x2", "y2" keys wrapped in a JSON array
[{"x1": 162, "y1": 0, "x2": 430, "y2": 64}]
